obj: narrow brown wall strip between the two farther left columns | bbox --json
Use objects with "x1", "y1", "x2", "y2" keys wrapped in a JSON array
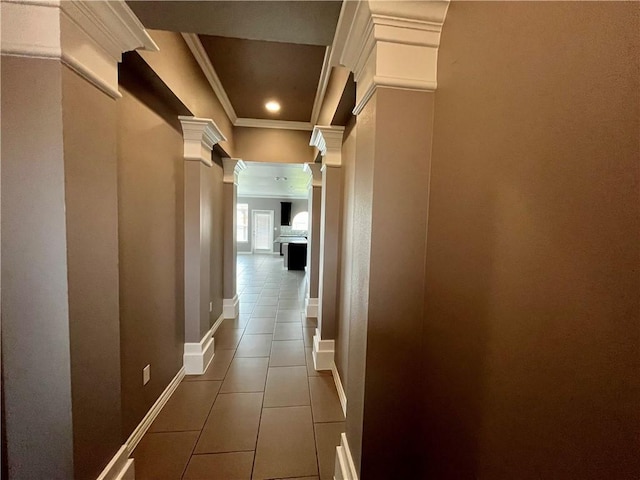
[{"x1": 209, "y1": 158, "x2": 224, "y2": 325}]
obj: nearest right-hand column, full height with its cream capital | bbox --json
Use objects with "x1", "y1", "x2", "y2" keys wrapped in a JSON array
[{"x1": 332, "y1": 0, "x2": 448, "y2": 480}]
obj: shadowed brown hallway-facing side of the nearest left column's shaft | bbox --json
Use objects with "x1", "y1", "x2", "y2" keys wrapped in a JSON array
[{"x1": 62, "y1": 64, "x2": 122, "y2": 479}]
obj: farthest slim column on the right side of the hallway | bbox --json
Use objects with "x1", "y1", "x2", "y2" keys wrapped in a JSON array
[{"x1": 304, "y1": 163, "x2": 322, "y2": 318}]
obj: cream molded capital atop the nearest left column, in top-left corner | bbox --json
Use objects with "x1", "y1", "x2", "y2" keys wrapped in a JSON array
[{"x1": 0, "y1": 0, "x2": 158, "y2": 98}]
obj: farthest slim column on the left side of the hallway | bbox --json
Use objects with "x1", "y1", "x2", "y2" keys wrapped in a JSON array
[{"x1": 222, "y1": 158, "x2": 246, "y2": 318}]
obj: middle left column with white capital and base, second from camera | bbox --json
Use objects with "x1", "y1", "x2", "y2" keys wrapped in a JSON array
[{"x1": 178, "y1": 117, "x2": 225, "y2": 375}]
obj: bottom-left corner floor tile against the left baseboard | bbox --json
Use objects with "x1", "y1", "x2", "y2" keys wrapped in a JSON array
[{"x1": 133, "y1": 432, "x2": 200, "y2": 480}]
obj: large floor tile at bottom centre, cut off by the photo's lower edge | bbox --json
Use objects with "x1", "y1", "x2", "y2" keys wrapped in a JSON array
[{"x1": 252, "y1": 407, "x2": 318, "y2": 480}]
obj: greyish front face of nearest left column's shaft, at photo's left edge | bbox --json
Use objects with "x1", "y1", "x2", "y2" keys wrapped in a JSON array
[{"x1": 2, "y1": 56, "x2": 73, "y2": 479}]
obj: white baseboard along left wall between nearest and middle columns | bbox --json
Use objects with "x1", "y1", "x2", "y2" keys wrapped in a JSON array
[{"x1": 98, "y1": 367, "x2": 184, "y2": 480}]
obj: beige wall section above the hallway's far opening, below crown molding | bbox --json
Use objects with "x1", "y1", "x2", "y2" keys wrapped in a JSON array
[{"x1": 234, "y1": 127, "x2": 315, "y2": 163}]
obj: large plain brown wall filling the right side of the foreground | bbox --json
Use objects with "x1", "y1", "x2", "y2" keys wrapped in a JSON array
[{"x1": 423, "y1": 2, "x2": 640, "y2": 479}]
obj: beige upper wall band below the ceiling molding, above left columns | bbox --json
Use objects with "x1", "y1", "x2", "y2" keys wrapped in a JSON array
[{"x1": 138, "y1": 30, "x2": 235, "y2": 156}]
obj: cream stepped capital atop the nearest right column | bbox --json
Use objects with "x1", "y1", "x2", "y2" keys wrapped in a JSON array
[{"x1": 336, "y1": 0, "x2": 449, "y2": 115}]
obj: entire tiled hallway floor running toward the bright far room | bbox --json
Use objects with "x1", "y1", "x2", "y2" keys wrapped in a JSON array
[{"x1": 133, "y1": 255, "x2": 344, "y2": 480}]
